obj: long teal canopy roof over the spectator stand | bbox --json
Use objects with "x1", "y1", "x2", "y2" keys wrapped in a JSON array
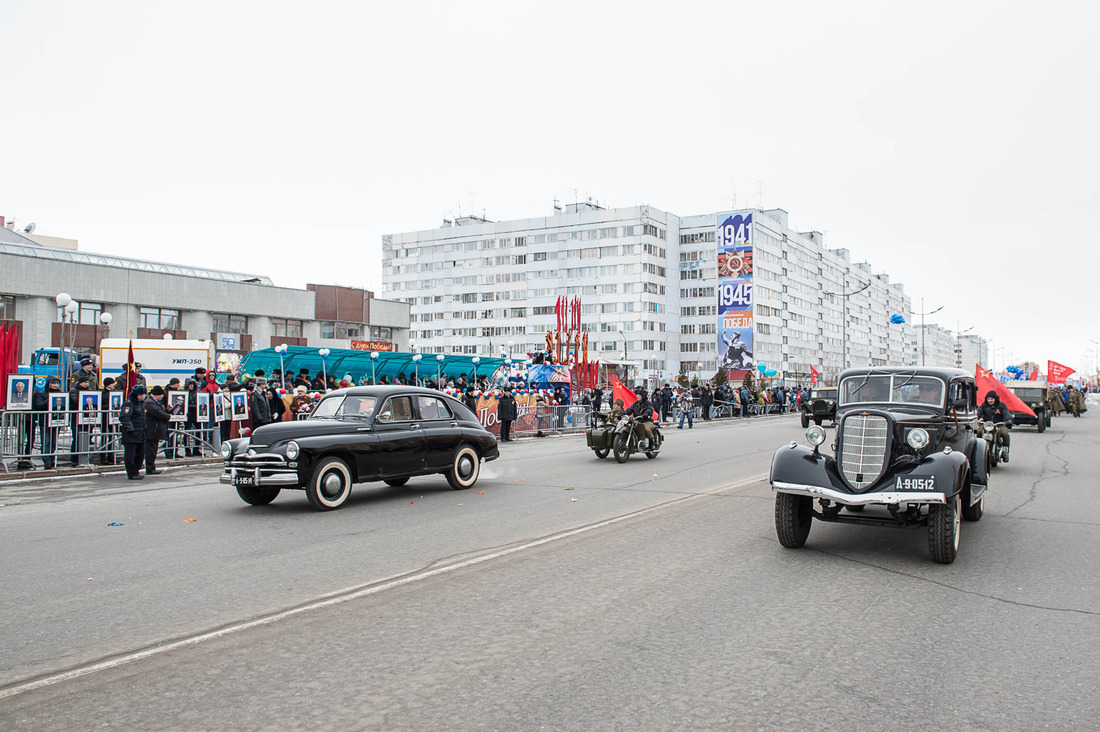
[{"x1": 241, "y1": 346, "x2": 504, "y2": 383}]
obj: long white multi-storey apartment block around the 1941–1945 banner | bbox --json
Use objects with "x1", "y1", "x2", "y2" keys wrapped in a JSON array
[{"x1": 383, "y1": 203, "x2": 912, "y2": 382}]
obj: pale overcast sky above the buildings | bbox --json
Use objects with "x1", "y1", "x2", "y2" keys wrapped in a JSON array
[{"x1": 0, "y1": 0, "x2": 1100, "y2": 371}]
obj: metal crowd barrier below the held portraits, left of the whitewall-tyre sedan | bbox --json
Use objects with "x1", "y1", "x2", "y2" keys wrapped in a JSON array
[{"x1": 0, "y1": 409, "x2": 221, "y2": 472}]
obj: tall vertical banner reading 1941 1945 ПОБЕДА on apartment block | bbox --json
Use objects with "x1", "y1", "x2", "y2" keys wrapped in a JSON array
[{"x1": 717, "y1": 211, "x2": 756, "y2": 370}]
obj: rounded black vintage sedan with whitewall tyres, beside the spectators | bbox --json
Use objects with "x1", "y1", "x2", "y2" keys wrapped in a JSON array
[{"x1": 220, "y1": 386, "x2": 499, "y2": 511}]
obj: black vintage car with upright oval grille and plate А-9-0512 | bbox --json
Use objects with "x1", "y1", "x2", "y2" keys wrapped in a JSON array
[{"x1": 770, "y1": 368, "x2": 989, "y2": 564}]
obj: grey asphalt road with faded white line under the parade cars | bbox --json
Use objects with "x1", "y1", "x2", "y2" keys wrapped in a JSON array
[{"x1": 0, "y1": 412, "x2": 1100, "y2": 730}]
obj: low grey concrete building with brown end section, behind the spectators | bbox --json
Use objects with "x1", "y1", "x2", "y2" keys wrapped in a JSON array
[{"x1": 0, "y1": 219, "x2": 409, "y2": 363}]
